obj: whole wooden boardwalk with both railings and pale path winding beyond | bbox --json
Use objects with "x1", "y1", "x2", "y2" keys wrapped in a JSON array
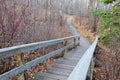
[{"x1": 0, "y1": 18, "x2": 98, "y2": 80}]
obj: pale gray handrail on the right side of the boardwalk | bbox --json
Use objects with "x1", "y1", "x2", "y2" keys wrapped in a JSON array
[{"x1": 67, "y1": 36, "x2": 98, "y2": 80}]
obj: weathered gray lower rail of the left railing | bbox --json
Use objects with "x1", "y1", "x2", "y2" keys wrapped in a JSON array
[{"x1": 0, "y1": 43, "x2": 74, "y2": 80}]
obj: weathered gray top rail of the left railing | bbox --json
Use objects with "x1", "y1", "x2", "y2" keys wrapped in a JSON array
[{"x1": 0, "y1": 35, "x2": 79, "y2": 59}]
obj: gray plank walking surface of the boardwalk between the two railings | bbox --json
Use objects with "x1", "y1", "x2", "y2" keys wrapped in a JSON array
[{"x1": 34, "y1": 36, "x2": 91, "y2": 80}]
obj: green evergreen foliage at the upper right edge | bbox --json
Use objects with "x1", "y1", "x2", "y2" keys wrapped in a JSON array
[{"x1": 92, "y1": 0, "x2": 120, "y2": 49}]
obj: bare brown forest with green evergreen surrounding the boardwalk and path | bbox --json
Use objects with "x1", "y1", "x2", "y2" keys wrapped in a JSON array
[{"x1": 0, "y1": 0, "x2": 120, "y2": 80}]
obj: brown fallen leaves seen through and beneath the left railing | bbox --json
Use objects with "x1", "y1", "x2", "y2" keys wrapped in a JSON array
[{"x1": 0, "y1": 43, "x2": 63, "y2": 80}]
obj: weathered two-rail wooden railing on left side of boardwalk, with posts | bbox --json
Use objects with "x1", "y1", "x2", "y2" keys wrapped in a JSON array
[{"x1": 0, "y1": 35, "x2": 80, "y2": 80}]
